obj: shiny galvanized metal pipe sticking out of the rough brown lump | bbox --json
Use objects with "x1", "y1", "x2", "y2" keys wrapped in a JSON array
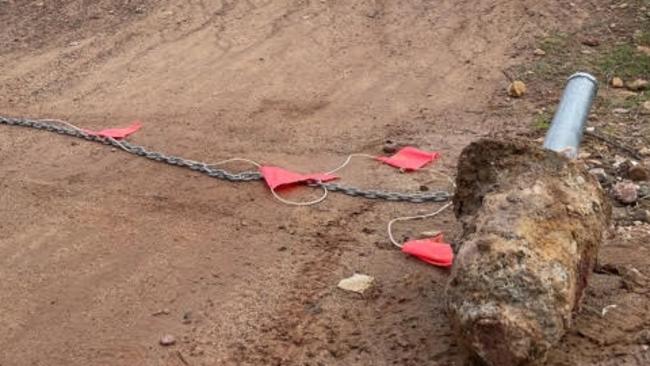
[{"x1": 544, "y1": 72, "x2": 598, "y2": 159}]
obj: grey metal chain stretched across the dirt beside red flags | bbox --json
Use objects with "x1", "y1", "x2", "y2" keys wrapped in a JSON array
[{"x1": 0, "y1": 116, "x2": 451, "y2": 203}]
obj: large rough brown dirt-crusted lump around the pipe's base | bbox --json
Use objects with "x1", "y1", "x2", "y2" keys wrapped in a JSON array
[{"x1": 446, "y1": 140, "x2": 611, "y2": 366}]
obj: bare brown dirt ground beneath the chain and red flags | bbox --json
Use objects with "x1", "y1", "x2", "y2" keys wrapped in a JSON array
[{"x1": 0, "y1": 0, "x2": 650, "y2": 366}]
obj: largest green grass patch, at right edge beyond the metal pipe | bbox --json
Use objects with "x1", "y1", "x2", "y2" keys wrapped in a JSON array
[{"x1": 597, "y1": 44, "x2": 650, "y2": 79}]
